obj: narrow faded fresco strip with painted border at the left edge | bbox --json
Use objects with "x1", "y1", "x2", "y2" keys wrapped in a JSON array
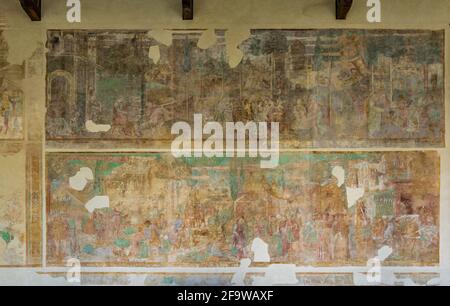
[{"x1": 0, "y1": 28, "x2": 45, "y2": 266}]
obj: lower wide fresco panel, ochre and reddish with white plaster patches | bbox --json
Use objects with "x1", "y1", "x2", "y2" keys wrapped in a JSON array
[{"x1": 47, "y1": 152, "x2": 440, "y2": 266}]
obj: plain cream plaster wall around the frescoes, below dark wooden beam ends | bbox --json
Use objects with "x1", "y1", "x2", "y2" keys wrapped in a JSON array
[{"x1": 0, "y1": 0, "x2": 450, "y2": 279}]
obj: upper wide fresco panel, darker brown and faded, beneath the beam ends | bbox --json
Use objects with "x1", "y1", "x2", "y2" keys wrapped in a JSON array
[{"x1": 46, "y1": 29, "x2": 445, "y2": 148}]
